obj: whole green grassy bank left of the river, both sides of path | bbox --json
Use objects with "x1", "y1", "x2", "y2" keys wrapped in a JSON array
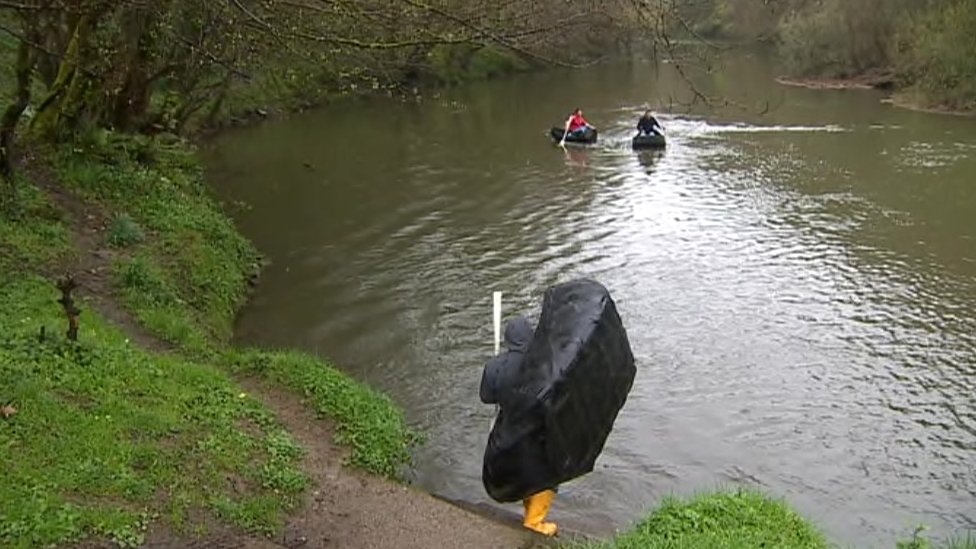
[{"x1": 0, "y1": 134, "x2": 415, "y2": 547}]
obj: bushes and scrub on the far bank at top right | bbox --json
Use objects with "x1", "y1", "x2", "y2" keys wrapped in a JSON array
[{"x1": 692, "y1": 0, "x2": 976, "y2": 111}]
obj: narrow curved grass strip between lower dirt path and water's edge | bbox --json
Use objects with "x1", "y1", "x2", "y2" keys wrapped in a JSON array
[{"x1": 233, "y1": 351, "x2": 419, "y2": 478}]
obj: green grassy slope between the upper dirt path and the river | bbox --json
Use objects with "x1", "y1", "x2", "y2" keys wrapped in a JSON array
[{"x1": 56, "y1": 133, "x2": 258, "y2": 349}]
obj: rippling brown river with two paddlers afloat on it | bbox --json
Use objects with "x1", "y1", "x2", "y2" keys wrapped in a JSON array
[{"x1": 205, "y1": 50, "x2": 976, "y2": 547}]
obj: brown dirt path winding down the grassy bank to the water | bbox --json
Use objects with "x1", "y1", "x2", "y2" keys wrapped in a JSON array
[{"x1": 30, "y1": 164, "x2": 552, "y2": 549}]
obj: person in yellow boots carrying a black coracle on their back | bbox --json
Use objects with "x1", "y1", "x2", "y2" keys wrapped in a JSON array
[{"x1": 480, "y1": 279, "x2": 636, "y2": 536}]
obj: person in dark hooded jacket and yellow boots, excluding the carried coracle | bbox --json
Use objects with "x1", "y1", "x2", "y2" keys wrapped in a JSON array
[{"x1": 479, "y1": 316, "x2": 558, "y2": 536}]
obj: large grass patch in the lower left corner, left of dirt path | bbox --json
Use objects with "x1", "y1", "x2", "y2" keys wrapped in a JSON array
[{"x1": 0, "y1": 278, "x2": 306, "y2": 547}]
